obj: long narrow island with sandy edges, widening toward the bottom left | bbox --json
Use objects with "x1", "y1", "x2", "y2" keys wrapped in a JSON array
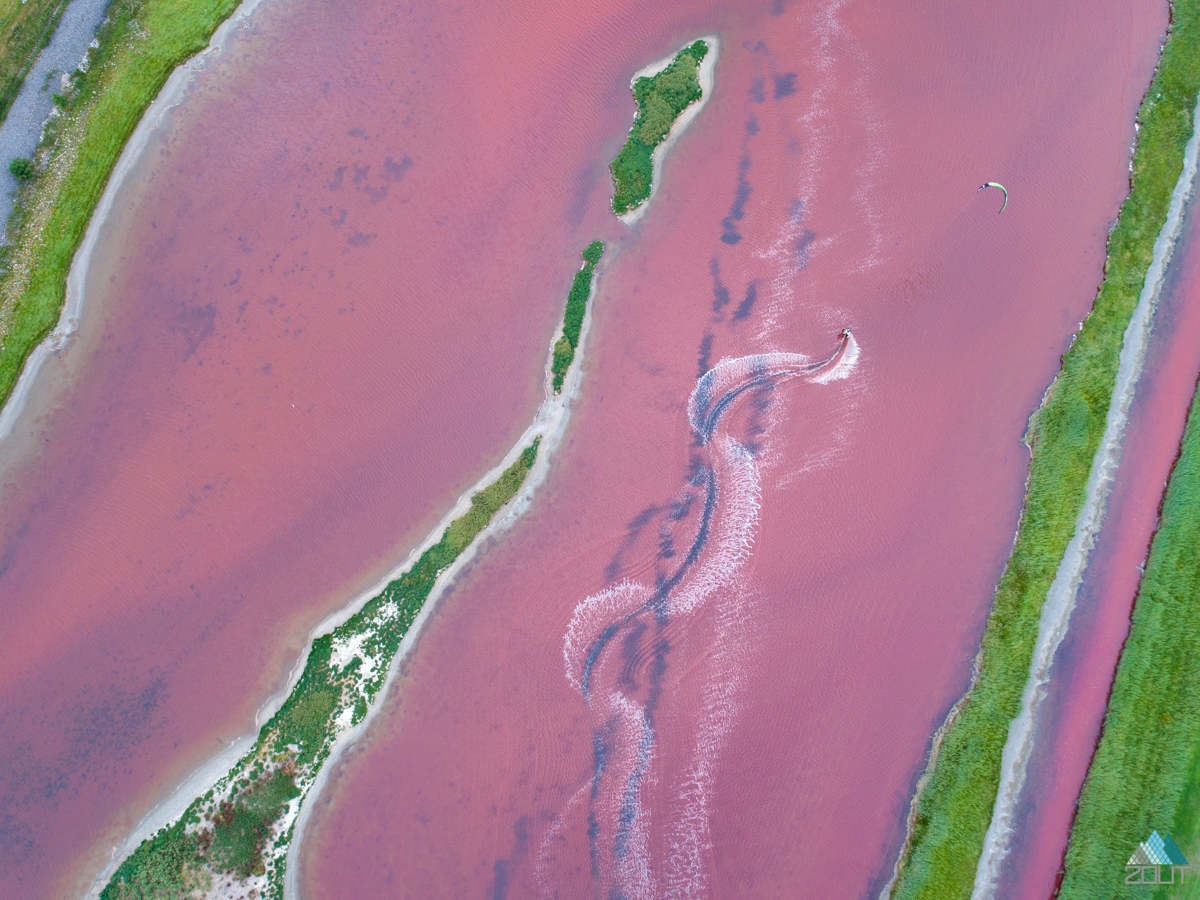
[{"x1": 100, "y1": 241, "x2": 604, "y2": 900}]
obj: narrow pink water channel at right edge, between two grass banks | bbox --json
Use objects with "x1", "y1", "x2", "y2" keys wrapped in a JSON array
[{"x1": 1000, "y1": 188, "x2": 1200, "y2": 900}]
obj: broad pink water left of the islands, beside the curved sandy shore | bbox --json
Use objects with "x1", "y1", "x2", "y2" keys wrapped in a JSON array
[{"x1": 0, "y1": 0, "x2": 625, "y2": 899}]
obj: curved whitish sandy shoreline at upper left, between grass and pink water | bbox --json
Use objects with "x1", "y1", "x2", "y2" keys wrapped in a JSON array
[{"x1": 0, "y1": 0, "x2": 262, "y2": 440}]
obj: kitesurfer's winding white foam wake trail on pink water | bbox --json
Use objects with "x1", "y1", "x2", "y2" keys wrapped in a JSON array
[{"x1": 538, "y1": 329, "x2": 858, "y2": 900}]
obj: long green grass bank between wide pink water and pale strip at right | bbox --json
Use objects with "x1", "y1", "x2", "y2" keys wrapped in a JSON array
[{"x1": 892, "y1": 0, "x2": 1200, "y2": 900}]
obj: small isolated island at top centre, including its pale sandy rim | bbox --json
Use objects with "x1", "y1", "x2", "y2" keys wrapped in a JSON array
[{"x1": 608, "y1": 37, "x2": 716, "y2": 222}]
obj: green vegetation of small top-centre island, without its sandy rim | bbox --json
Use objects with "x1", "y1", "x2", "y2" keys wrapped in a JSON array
[{"x1": 608, "y1": 41, "x2": 709, "y2": 222}]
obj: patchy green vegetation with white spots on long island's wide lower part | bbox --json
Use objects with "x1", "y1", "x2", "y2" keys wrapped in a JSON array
[{"x1": 100, "y1": 438, "x2": 541, "y2": 900}]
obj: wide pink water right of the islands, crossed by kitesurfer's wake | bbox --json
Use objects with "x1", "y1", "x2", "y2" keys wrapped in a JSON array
[{"x1": 292, "y1": 0, "x2": 1166, "y2": 900}]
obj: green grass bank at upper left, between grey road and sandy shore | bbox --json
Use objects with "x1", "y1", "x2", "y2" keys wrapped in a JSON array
[{"x1": 0, "y1": 0, "x2": 238, "y2": 403}]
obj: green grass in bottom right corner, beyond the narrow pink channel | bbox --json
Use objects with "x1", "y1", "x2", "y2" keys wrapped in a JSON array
[{"x1": 1060, "y1": 376, "x2": 1200, "y2": 900}]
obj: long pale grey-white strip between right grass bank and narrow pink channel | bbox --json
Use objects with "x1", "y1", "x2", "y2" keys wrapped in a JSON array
[{"x1": 971, "y1": 88, "x2": 1200, "y2": 900}]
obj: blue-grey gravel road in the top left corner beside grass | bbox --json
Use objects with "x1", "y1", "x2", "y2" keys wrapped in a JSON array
[{"x1": 0, "y1": 0, "x2": 108, "y2": 234}]
